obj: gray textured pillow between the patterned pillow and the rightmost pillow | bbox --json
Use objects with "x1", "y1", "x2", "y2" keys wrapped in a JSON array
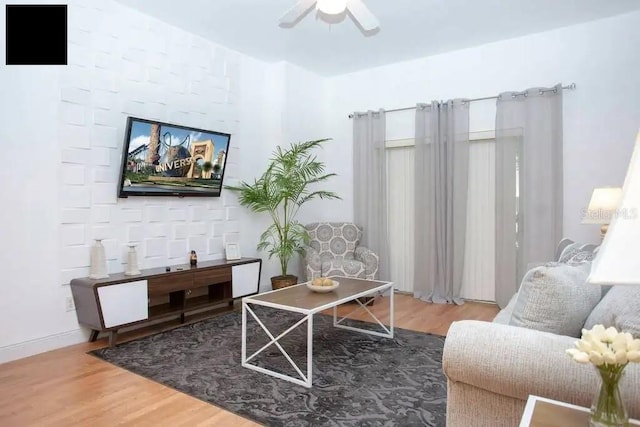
[{"x1": 509, "y1": 263, "x2": 601, "y2": 337}]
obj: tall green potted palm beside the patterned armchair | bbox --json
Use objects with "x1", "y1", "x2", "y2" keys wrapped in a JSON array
[{"x1": 225, "y1": 139, "x2": 340, "y2": 289}]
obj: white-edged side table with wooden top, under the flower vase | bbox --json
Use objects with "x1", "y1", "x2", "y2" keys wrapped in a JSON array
[{"x1": 520, "y1": 396, "x2": 640, "y2": 427}]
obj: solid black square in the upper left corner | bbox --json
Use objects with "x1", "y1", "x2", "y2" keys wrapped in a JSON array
[{"x1": 6, "y1": 4, "x2": 67, "y2": 65}]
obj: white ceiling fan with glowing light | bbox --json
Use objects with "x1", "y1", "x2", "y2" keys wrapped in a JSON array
[{"x1": 280, "y1": 0, "x2": 380, "y2": 31}]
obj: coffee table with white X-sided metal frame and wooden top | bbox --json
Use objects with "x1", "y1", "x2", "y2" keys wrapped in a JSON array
[{"x1": 242, "y1": 277, "x2": 393, "y2": 387}]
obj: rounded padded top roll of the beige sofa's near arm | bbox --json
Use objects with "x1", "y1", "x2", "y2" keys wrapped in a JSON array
[{"x1": 442, "y1": 320, "x2": 640, "y2": 418}]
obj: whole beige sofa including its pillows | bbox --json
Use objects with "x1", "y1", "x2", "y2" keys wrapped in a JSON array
[{"x1": 442, "y1": 239, "x2": 640, "y2": 427}]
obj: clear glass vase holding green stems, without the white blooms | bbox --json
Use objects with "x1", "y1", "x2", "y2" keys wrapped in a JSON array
[{"x1": 589, "y1": 365, "x2": 629, "y2": 427}]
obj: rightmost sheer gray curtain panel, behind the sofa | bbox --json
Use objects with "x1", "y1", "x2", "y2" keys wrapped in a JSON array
[{"x1": 495, "y1": 85, "x2": 563, "y2": 307}]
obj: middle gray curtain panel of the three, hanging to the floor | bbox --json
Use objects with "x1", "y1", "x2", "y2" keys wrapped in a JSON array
[{"x1": 414, "y1": 99, "x2": 469, "y2": 304}]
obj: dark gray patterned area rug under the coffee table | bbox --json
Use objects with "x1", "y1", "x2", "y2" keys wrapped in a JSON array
[{"x1": 91, "y1": 308, "x2": 447, "y2": 426}]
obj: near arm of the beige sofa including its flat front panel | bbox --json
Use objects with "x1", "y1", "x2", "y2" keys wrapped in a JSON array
[{"x1": 442, "y1": 320, "x2": 640, "y2": 427}]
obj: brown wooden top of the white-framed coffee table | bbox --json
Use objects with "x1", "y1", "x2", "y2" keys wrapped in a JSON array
[{"x1": 243, "y1": 276, "x2": 392, "y2": 312}]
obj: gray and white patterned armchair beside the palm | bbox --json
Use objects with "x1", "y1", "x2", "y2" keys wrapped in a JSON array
[{"x1": 304, "y1": 222, "x2": 378, "y2": 280}]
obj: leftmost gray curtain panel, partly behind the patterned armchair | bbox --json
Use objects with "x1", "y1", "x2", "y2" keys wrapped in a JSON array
[{"x1": 353, "y1": 110, "x2": 391, "y2": 280}]
